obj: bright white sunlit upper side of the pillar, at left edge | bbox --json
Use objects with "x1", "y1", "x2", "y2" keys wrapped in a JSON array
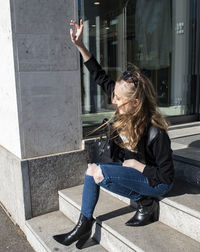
[{"x1": 0, "y1": 1, "x2": 21, "y2": 157}]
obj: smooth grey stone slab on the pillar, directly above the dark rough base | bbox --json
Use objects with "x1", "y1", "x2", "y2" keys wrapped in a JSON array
[{"x1": 20, "y1": 71, "x2": 82, "y2": 158}]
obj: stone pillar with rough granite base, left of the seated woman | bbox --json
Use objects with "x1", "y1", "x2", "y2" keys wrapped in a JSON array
[{"x1": 0, "y1": 0, "x2": 87, "y2": 232}]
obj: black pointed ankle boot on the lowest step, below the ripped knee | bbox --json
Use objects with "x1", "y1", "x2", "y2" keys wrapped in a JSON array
[{"x1": 53, "y1": 214, "x2": 95, "y2": 248}]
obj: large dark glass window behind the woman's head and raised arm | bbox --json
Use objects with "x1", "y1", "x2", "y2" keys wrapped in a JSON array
[{"x1": 79, "y1": 0, "x2": 193, "y2": 126}]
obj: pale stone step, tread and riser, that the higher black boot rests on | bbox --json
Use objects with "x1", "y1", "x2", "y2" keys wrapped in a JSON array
[{"x1": 59, "y1": 186, "x2": 200, "y2": 252}]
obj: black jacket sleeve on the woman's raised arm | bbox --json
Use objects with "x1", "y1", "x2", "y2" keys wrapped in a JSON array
[{"x1": 84, "y1": 55, "x2": 115, "y2": 101}]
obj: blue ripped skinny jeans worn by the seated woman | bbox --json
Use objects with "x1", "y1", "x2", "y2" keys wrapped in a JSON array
[{"x1": 81, "y1": 162, "x2": 173, "y2": 219}]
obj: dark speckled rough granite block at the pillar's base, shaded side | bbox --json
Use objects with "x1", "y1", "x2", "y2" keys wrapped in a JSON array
[{"x1": 27, "y1": 151, "x2": 87, "y2": 217}]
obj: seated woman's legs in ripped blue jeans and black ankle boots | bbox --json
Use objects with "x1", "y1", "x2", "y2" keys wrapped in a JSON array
[{"x1": 53, "y1": 162, "x2": 173, "y2": 248}]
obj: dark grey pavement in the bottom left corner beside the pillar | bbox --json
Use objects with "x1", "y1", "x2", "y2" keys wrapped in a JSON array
[{"x1": 0, "y1": 206, "x2": 34, "y2": 252}]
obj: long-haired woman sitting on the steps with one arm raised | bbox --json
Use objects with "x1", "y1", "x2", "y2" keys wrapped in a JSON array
[{"x1": 54, "y1": 20, "x2": 174, "y2": 247}]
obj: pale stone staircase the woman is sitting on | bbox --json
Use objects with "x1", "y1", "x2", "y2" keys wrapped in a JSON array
[{"x1": 25, "y1": 123, "x2": 200, "y2": 252}]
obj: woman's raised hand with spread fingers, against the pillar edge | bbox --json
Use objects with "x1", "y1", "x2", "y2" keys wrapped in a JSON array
[{"x1": 70, "y1": 19, "x2": 83, "y2": 46}]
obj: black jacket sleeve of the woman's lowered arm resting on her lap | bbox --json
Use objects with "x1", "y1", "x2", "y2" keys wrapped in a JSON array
[{"x1": 143, "y1": 130, "x2": 174, "y2": 186}]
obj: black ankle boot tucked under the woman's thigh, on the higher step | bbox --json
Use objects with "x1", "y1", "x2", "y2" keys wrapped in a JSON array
[{"x1": 125, "y1": 197, "x2": 159, "y2": 226}]
